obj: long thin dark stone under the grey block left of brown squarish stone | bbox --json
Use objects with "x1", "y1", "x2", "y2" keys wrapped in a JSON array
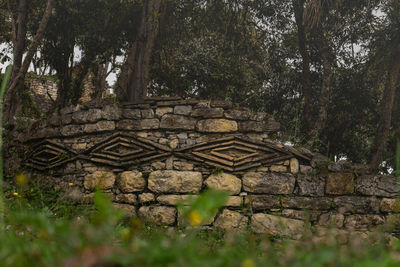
[{"x1": 281, "y1": 197, "x2": 335, "y2": 210}]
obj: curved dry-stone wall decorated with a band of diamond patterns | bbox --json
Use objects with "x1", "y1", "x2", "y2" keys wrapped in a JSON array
[{"x1": 13, "y1": 99, "x2": 400, "y2": 239}]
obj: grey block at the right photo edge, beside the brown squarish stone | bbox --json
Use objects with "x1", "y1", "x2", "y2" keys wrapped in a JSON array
[{"x1": 356, "y1": 175, "x2": 400, "y2": 197}]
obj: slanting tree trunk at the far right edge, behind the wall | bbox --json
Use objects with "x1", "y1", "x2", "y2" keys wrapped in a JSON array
[{"x1": 369, "y1": 44, "x2": 400, "y2": 171}]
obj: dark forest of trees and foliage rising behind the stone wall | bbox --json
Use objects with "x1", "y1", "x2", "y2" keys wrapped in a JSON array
[{"x1": 0, "y1": 0, "x2": 400, "y2": 172}]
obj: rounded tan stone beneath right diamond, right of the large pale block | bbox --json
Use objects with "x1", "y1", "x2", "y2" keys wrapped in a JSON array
[{"x1": 204, "y1": 173, "x2": 242, "y2": 195}]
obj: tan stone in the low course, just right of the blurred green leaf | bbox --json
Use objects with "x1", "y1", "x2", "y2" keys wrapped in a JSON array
[{"x1": 214, "y1": 209, "x2": 249, "y2": 230}]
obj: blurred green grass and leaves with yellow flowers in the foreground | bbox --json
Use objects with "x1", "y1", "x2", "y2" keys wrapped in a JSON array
[{"x1": 0, "y1": 181, "x2": 400, "y2": 267}]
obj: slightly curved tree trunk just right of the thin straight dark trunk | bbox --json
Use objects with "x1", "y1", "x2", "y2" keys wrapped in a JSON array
[{"x1": 307, "y1": 30, "x2": 335, "y2": 148}]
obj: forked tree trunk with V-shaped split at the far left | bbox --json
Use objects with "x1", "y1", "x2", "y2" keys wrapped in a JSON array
[{"x1": 3, "y1": 0, "x2": 54, "y2": 122}]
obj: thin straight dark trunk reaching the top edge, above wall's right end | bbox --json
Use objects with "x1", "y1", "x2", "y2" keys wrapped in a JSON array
[{"x1": 293, "y1": 0, "x2": 313, "y2": 131}]
